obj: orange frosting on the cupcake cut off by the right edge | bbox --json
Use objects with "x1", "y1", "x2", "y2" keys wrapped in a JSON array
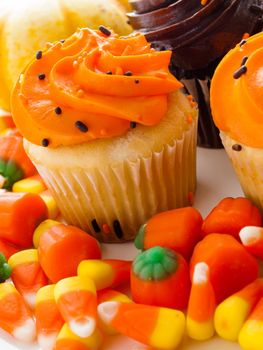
[{"x1": 211, "y1": 33, "x2": 263, "y2": 148}]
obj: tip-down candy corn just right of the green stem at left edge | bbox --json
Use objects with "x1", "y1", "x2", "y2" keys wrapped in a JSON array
[{"x1": 8, "y1": 249, "x2": 48, "y2": 309}]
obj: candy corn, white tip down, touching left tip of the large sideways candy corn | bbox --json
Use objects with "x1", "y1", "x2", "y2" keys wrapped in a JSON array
[{"x1": 55, "y1": 276, "x2": 97, "y2": 338}]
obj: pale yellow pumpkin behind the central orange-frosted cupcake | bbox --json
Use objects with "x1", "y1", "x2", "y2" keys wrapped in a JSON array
[{"x1": 0, "y1": 0, "x2": 131, "y2": 110}]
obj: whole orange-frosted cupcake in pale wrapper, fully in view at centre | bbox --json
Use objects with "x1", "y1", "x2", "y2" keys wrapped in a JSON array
[{"x1": 12, "y1": 27, "x2": 197, "y2": 242}]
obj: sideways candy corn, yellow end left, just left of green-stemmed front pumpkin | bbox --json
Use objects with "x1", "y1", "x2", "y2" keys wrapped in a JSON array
[{"x1": 78, "y1": 259, "x2": 131, "y2": 290}]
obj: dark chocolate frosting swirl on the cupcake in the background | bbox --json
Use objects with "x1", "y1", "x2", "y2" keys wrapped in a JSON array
[{"x1": 128, "y1": 0, "x2": 263, "y2": 70}]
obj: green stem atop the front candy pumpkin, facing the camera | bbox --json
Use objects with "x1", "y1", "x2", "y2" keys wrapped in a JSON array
[{"x1": 132, "y1": 247, "x2": 178, "y2": 281}]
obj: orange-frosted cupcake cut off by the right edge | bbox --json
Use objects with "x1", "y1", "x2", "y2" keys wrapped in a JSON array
[{"x1": 211, "y1": 33, "x2": 263, "y2": 209}]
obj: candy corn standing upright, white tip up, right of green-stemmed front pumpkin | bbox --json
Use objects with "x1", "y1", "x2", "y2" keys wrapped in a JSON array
[{"x1": 186, "y1": 262, "x2": 216, "y2": 340}]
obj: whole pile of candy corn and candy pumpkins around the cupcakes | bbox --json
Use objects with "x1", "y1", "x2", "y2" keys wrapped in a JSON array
[{"x1": 0, "y1": 114, "x2": 263, "y2": 350}]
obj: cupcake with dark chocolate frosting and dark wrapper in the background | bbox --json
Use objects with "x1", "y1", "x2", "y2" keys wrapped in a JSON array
[{"x1": 128, "y1": 0, "x2": 263, "y2": 148}]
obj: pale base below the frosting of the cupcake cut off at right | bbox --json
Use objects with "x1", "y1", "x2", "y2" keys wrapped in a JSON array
[{"x1": 223, "y1": 132, "x2": 263, "y2": 210}]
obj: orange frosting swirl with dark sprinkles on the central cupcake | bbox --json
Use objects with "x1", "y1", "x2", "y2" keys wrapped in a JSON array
[{"x1": 12, "y1": 28, "x2": 182, "y2": 147}]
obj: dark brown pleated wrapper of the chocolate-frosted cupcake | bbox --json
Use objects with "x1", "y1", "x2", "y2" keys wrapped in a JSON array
[{"x1": 181, "y1": 77, "x2": 223, "y2": 148}]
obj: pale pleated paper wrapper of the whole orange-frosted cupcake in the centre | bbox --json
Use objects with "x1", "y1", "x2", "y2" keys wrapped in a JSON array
[{"x1": 35, "y1": 122, "x2": 196, "y2": 242}]
